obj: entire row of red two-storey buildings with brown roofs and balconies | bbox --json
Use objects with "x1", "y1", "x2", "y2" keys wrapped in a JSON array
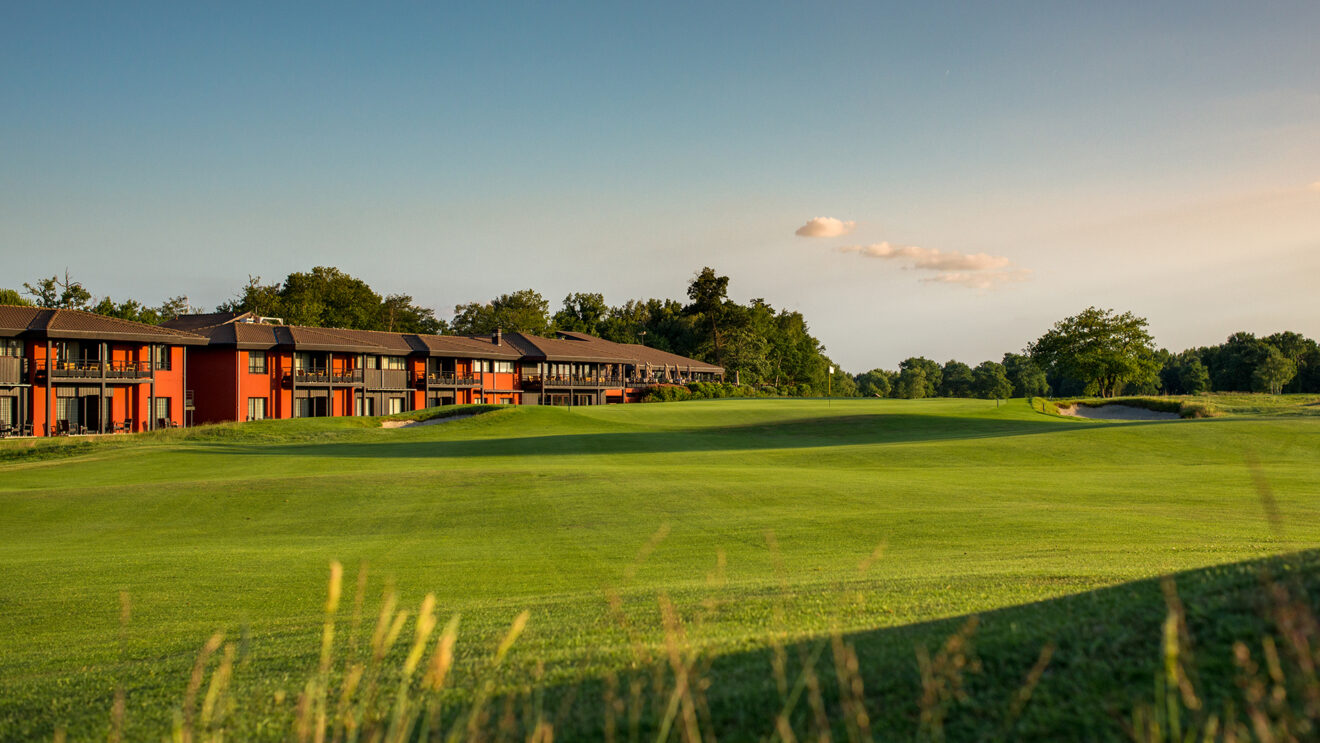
[{"x1": 0, "y1": 306, "x2": 723, "y2": 436}]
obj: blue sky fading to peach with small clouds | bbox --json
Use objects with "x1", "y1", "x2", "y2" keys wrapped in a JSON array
[{"x1": 0, "y1": 0, "x2": 1320, "y2": 372}]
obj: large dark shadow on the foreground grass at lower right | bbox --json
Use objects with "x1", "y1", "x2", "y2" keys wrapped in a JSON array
[{"x1": 530, "y1": 550, "x2": 1320, "y2": 740}]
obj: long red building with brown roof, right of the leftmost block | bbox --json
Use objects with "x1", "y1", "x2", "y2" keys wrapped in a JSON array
[{"x1": 165, "y1": 313, "x2": 723, "y2": 422}]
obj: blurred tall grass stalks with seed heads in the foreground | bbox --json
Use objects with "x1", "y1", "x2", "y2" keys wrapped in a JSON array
[{"x1": 55, "y1": 551, "x2": 1320, "y2": 743}]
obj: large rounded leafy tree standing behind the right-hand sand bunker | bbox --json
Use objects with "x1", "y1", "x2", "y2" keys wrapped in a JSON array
[{"x1": 1030, "y1": 307, "x2": 1159, "y2": 397}]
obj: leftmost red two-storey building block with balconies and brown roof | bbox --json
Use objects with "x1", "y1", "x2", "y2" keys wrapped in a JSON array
[{"x1": 0, "y1": 305, "x2": 206, "y2": 436}]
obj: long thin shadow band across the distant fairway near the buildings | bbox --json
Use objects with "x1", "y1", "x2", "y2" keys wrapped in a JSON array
[{"x1": 188, "y1": 414, "x2": 1167, "y2": 458}]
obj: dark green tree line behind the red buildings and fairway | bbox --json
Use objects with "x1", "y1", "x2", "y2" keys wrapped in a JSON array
[{"x1": 0, "y1": 273, "x2": 1320, "y2": 399}]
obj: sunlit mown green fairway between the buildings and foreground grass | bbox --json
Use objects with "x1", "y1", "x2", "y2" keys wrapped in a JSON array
[{"x1": 0, "y1": 400, "x2": 1320, "y2": 739}]
